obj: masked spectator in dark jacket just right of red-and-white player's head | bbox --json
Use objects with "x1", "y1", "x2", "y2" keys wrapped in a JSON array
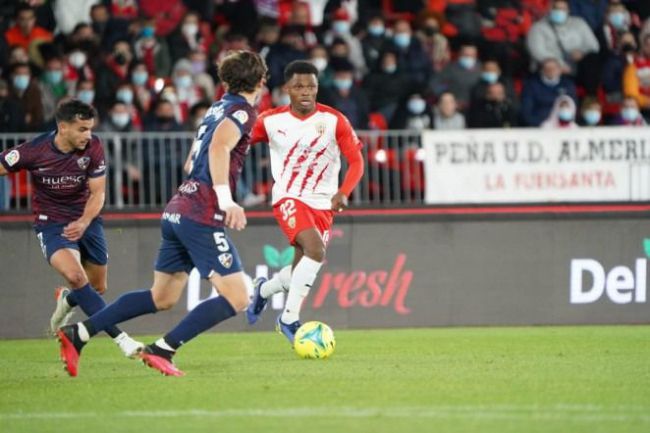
[{"x1": 319, "y1": 59, "x2": 368, "y2": 129}]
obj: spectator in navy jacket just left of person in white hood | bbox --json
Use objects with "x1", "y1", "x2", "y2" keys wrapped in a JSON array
[{"x1": 521, "y1": 59, "x2": 577, "y2": 126}]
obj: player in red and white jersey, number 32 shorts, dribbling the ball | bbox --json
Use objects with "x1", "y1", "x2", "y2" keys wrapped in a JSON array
[{"x1": 247, "y1": 61, "x2": 363, "y2": 343}]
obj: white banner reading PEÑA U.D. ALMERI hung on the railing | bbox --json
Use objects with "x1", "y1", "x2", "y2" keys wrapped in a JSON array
[{"x1": 423, "y1": 127, "x2": 650, "y2": 204}]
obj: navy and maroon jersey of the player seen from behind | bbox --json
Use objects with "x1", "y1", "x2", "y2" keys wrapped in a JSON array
[{"x1": 165, "y1": 93, "x2": 257, "y2": 227}]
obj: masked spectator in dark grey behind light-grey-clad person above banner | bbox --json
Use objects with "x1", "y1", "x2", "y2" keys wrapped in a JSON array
[{"x1": 430, "y1": 42, "x2": 481, "y2": 110}]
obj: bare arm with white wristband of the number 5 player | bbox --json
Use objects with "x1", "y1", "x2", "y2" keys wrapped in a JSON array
[{"x1": 209, "y1": 119, "x2": 246, "y2": 230}]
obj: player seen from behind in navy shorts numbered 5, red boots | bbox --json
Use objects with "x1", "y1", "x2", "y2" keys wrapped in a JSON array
[{"x1": 58, "y1": 51, "x2": 267, "y2": 376}]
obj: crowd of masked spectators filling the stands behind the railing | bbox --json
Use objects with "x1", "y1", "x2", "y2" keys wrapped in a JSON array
[{"x1": 0, "y1": 0, "x2": 650, "y2": 132}]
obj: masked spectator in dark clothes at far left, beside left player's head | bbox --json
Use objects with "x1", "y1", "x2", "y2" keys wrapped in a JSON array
[{"x1": 9, "y1": 63, "x2": 43, "y2": 132}]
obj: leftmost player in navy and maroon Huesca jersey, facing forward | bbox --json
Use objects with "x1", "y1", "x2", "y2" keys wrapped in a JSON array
[{"x1": 0, "y1": 99, "x2": 143, "y2": 357}]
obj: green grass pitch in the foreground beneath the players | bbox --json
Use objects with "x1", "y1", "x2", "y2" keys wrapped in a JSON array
[{"x1": 0, "y1": 326, "x2": 650, "y2": 433}]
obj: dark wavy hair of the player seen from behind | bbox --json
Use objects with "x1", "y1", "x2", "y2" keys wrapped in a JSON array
[{"x1": 219, "y1": 50, "x2": 268, "y2": 93}]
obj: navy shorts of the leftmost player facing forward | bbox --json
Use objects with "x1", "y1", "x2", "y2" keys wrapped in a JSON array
[{"x1": 34, "y1": 218, "x2": 108, "y2": 265}]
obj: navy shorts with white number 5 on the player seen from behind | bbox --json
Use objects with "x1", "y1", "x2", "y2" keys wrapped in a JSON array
[{"x1": 155, "y1": 217, "x2": 242, "y2": 278}]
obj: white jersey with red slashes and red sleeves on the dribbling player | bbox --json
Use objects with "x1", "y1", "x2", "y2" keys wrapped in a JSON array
[{"x1": 251, "y1": 104, "x2": 361, "y2": 209}]
